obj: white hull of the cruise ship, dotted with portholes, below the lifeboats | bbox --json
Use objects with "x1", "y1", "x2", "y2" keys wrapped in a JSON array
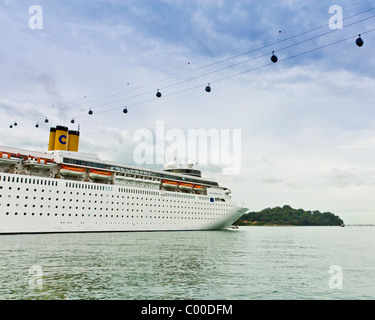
[{"x1": 0, "y1": 173, "x2": 246, "y2": 234}]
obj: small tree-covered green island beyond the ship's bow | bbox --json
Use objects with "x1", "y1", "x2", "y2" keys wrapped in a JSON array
[{"x1": 234, "y1": 205, "x2": 344, "y2": 226}]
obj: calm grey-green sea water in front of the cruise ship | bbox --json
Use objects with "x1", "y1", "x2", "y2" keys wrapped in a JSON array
[{"x1": 0, "y1": 226, "x2": 375, "y2": 300}]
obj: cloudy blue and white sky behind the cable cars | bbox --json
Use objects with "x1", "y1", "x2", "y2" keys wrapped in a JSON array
[{"x1": 0, "y1": 0, "x2": 375, "y2": 224}]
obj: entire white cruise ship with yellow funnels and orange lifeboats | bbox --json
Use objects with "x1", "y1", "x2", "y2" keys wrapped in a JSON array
[{"x1": 0, "y1": 126, "x2": 247, "y2": 234}]
